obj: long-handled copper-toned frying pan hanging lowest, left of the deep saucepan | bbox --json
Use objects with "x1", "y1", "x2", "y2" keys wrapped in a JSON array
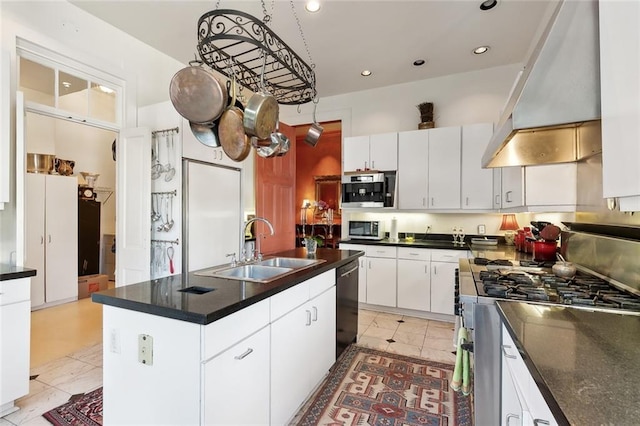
[{"x1": 218, "y1": 76, "x2": 251, "y2": 161}]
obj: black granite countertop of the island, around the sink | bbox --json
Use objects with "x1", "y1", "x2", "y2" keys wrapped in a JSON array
[{"x1": 91, "y1": 248, "x2": 363, "y2": 324}]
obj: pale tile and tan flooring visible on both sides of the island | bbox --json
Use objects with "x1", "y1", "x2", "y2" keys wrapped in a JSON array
[{"x1": 0, "y1": 299, "x2": 455, "y2": 426}]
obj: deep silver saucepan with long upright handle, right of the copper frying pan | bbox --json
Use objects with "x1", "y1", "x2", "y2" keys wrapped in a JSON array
[{"x1": 243, "y1": 53, "x2": 278, "y2": 139}]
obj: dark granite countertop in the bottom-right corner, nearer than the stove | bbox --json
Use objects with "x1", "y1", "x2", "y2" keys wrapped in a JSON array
[{"x1": 497, "y1": 301, "x2": 640, "y2": 425}]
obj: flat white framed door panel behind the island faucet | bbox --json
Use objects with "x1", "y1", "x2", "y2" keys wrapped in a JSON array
[{"x1": 183, "y1": 161, "x2": 242, "y2": 271}]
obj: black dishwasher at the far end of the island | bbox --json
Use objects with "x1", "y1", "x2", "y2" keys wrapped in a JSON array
[{"x1": 336, "y1": 260, "x2": 358, "y2": 359}]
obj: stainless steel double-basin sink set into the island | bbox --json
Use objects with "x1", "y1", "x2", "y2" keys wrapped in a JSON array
[{"x1": 195, "y1": 257, "x2": 325, "y2": 283}]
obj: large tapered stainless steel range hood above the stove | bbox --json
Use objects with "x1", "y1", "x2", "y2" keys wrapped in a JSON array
[{"x1": 482, "y1": 0, "x2": 602, "y2": 167}]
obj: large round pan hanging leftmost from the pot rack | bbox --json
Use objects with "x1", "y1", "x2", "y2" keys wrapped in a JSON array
[{"x1": 169, "y1": 61, "x2": 228, "y2": 124}]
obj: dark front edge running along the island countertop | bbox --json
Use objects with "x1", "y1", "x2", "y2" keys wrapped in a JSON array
[{"x1": 91, "y1": 250, "x2": 364, "y2": 325}]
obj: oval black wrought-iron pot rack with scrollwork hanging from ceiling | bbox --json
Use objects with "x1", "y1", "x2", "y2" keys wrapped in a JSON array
[{"x1": 198, "y1": 9, "x2": 316, "y2": 105}]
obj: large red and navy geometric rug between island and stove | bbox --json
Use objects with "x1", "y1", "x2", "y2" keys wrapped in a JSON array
[{"x1": 293, "y1": 345, "x2": 473, "y2": 426}]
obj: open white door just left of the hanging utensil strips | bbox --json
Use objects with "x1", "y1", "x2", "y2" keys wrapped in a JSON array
[{"x1": 116, "y1": 128, "x2": 151, "y2": 287}]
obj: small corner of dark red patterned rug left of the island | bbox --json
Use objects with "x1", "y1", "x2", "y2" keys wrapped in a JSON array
[{"x1": 42, "y1": 387, "x2": 102, "y2": 426}]
